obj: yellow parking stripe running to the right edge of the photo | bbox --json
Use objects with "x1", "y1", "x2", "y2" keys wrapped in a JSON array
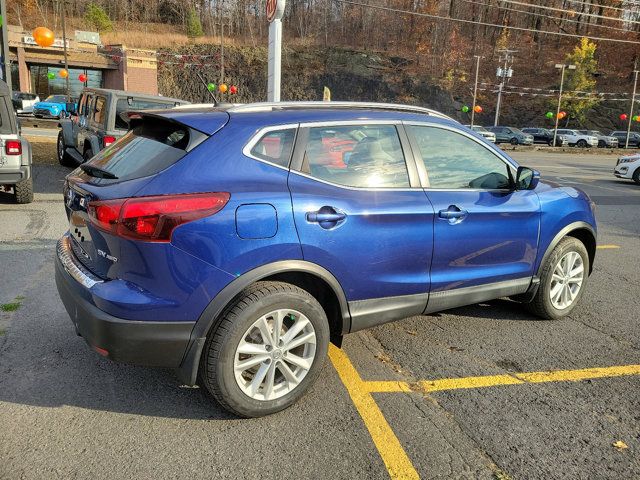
[{"x1": 362, "y1": 365, "x2": 640, "y2": 393}]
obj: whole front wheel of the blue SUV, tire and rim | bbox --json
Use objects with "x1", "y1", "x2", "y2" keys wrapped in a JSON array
[{"x1": 527, "y1": 237, "x2": 589, "y2": 320}]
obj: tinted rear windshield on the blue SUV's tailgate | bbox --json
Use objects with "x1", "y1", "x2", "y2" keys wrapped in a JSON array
[{"x1": 89, "y1": 119, "x2": 192, "y2": 181}]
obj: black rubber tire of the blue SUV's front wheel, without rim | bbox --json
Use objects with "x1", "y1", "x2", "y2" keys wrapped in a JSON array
[{"x1": 526, "y1": 237, "x2": 589, "y2": 320}]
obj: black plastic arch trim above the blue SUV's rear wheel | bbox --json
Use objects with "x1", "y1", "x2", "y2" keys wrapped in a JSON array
[{"x1": 177, "y1": 260, "x2": 351, "y2": 385}]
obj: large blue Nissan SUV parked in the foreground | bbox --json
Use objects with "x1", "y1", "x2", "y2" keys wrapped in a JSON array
[{"x1": 56, "y1": 102, "x2": 596, "y2": 417}]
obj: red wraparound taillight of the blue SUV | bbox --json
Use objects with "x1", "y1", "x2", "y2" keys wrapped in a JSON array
[{"x1": 87, "y1": 192, "x2": 230, "y2": 242}]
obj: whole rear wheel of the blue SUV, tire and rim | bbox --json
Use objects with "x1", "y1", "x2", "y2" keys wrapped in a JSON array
[{"x1": 200, "y1": 282, "x2": 329, "y2": 417}]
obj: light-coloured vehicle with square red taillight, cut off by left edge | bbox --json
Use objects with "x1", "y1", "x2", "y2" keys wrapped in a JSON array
[{"x1": 0, "y1": 80, "x2": 33, "y2": 203}]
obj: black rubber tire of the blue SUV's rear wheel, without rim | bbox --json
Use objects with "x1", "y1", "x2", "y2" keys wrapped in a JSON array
[{"x1": 200, "y1": 282, "x2": 329, "y2": 418}]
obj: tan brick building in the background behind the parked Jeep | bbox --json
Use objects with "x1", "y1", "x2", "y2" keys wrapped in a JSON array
[{"x1": 8, "y1": 25, "x2": 158, "y2": 98}]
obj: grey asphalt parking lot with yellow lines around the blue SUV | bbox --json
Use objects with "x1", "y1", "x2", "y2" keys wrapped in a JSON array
[{"x1": 0, "y1": 143, "x2": 640, "y2": 479}]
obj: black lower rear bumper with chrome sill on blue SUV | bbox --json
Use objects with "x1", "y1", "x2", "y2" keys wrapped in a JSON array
[{"x1": 55, "y1": 235, "x2": 195, "y2": 368}]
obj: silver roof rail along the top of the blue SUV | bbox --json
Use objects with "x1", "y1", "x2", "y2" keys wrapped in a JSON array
[{"x1": 227, "y1": 101, "x2": 455, "y2": 121}]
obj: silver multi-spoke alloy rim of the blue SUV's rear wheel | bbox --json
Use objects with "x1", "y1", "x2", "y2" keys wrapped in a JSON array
[{"x1": 233, "y1": 309, "x2": 316, "y2": 401}]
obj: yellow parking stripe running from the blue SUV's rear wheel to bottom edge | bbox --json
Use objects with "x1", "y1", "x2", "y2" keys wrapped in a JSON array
[{"x1": 329, "y1": 344, "x2": 420, "y2": 479}]
